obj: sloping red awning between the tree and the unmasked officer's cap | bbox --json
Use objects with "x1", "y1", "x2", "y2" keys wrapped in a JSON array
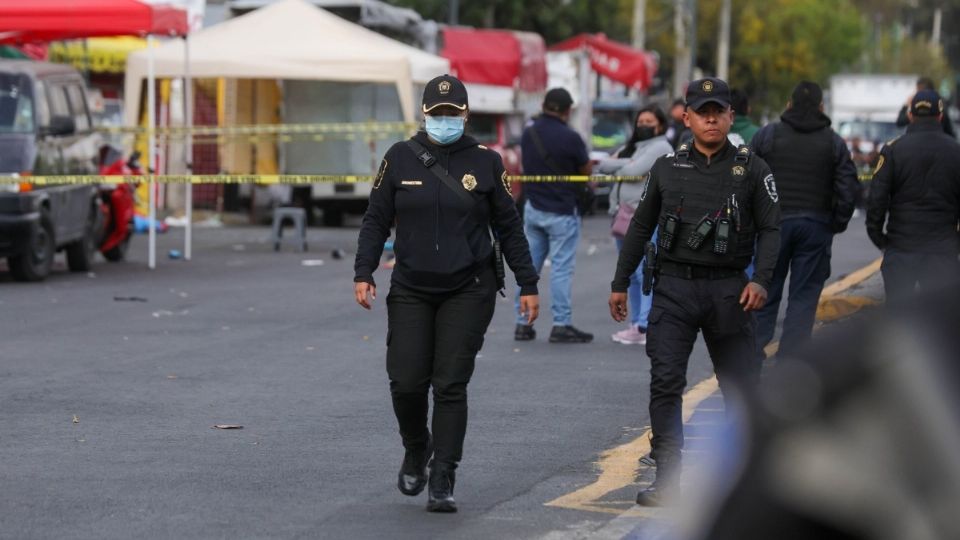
[{"x1": 550, "y1": 34, "x2": 657, "y2": 90}]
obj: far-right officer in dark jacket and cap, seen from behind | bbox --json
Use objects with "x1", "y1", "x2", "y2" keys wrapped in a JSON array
[{"x1": 867, "y1": 90, "x2": 960, "y2": 305}]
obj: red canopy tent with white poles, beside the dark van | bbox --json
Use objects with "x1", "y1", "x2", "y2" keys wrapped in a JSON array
[{"x1": 0, "y1": 0, "x2": 193, "y2": 268}]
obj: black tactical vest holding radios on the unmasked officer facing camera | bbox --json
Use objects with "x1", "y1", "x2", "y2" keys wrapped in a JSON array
[{"x1": 659, "y1": 143, "x2": 762, "y2": 269}]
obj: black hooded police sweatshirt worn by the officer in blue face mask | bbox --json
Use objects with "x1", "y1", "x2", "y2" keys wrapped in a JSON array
[{"x1": 354, "y1": 131, "x2": 538, "y2": 295}]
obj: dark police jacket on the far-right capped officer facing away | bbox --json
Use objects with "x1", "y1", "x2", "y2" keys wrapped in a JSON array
[{"x1": 867, "y1": 119, "x2": 960, "y2": 253}]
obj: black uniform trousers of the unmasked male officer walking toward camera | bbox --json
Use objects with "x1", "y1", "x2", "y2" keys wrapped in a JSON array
[{"x1": 647, "y1": 275, "x2": 760, "y2": 467}]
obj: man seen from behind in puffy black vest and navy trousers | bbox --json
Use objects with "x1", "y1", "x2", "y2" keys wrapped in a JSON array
[{"x1": 752, "y1": 81, "x2": 860, "y2": 355}]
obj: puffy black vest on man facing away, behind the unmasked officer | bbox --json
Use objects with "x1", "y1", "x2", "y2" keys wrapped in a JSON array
[{"x1": 763, "y1": 122, "x2": 835, "y2": 215}]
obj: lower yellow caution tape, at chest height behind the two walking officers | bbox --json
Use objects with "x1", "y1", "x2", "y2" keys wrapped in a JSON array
[{"x1": 0, "y1": 174, "x2": 646, "y2": 186}]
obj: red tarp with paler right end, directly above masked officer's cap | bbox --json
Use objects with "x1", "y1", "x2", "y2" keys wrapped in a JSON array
[{"x1": 440, "y1": 27, "x2": 547, "y2": 92}]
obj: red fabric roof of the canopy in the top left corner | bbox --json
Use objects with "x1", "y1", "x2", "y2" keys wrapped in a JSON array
[{"x1": 0, "y1": 0, "x2": 187, "y2": 43}]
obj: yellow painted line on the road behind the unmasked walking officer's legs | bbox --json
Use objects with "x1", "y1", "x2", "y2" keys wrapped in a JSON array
[{"x1": 544, "y1": 259, "x2": 882, "y2": 517}]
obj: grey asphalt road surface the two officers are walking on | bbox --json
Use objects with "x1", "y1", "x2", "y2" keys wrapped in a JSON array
[{"x1": 0, "y1": 212, "x2": 878, "y2": 539}]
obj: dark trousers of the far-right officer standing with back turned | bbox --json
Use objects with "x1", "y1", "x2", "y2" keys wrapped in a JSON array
[{"x1": 880, "y1": 248, "x2": 960, "y2": 307}]
